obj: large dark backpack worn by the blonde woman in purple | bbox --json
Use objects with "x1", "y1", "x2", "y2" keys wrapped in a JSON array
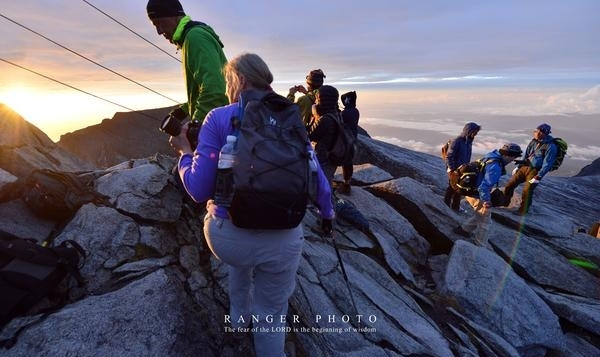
[{"x1": 228, "y1": 90, "x2": 313, "y2": 229}]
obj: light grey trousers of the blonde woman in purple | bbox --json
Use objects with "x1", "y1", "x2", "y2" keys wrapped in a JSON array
[{"x1": 204, "y1": 214, "x2": 304, "y2": 356}]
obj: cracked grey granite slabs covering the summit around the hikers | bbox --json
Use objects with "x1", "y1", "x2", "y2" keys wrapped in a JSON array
[{"x1": 0, "y1": 107, "x2": 600, "y2": 357}]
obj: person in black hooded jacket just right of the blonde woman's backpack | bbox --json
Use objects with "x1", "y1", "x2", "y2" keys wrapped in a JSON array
[{"x1": 307, "y1": 85, "x2": 340, "y2": 185}]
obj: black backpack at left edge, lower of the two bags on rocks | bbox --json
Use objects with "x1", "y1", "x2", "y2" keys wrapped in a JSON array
[{"x1": 0, "y1": 232, "x2": 86, "y2": 328}]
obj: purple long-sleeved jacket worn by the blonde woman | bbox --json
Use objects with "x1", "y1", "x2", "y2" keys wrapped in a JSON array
[{"x1": 178, "y1": 103, "x2": 334, "y2": 219}]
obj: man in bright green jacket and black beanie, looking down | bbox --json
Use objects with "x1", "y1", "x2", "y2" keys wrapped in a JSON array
[{"x1": 146, "y1": 0, "x2": 229, "y2": 123}]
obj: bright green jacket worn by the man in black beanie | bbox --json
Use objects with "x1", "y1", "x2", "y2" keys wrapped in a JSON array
[{"x1": 173, "y1": 16, "x2": 229, "y2": 122}]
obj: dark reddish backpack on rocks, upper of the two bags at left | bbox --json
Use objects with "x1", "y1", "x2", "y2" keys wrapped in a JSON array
[{"x1": 22, "y1": 169, "x2": 108, "y2": 221}]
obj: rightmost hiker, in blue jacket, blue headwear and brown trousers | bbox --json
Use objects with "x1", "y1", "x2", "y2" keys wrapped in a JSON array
[{"x1": 504, "y1": 124, "x2": 558, "y2": 216}]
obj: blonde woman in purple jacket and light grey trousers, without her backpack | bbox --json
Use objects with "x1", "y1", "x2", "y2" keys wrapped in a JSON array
[{"x1": 170, "y1": 53, "x2": 334, "y2": 356}]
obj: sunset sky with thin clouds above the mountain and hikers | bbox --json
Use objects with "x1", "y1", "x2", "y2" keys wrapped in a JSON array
[{"x1": 0, "y1": 0, "x2": 600, "y2": 172}]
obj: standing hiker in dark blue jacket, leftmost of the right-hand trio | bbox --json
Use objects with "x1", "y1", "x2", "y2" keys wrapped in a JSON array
[{"x1": 444, "y1": 122, "x2": 481, "y2": 212}]
